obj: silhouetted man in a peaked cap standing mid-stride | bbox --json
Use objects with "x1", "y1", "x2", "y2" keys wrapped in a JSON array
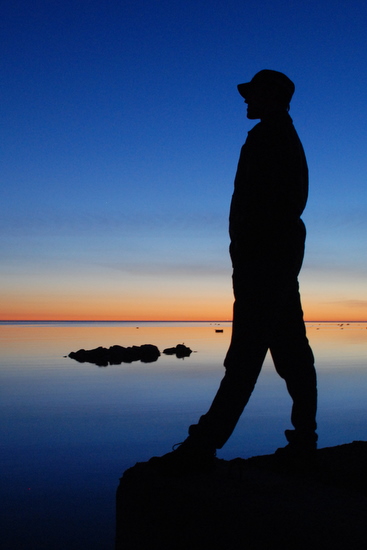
[{"x1": 151, "y1": 70, "x2": 317, "y2": 471}]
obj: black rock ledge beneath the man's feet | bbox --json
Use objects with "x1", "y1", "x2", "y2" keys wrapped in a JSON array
[{"x1": 116, "y1": 441, "x2": 367, "y2": 550}]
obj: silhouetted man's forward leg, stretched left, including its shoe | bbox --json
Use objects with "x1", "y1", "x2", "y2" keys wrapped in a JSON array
[{"x1": 150, "y1": 294, "x2": 268, "y2": 474}]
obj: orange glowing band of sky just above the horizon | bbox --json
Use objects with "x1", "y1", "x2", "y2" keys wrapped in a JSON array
[{"x1": 0, "y1": 293, "x2": 367, "y2": 322}]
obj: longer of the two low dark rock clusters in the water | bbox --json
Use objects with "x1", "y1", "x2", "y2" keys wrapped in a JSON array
[{"x1": 68, "y1": 344, "x2": 160, "y2": 367}]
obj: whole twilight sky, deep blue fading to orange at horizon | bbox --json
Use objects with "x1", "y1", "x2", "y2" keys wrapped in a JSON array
[{"x1": 0, "y1": 0, "x2": 367, "y2": 321}]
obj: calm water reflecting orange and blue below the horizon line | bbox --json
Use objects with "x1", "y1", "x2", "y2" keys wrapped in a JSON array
[{"x1": 0, "y1": 323, "x2": 367, "y2": 550}]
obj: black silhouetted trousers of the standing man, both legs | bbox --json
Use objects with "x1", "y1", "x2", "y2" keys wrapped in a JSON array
[{"x1": 194, "y1": 235, "x2": 317, "y2": 449}]
